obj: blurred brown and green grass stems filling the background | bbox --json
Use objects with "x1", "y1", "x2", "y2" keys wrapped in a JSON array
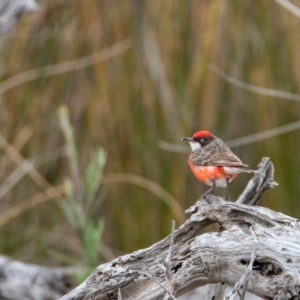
[{"x1": 0, "y1": 0, "x2": 300, "y2": 265}]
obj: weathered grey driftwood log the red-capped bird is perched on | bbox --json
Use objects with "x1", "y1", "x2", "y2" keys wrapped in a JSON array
[{"x1": 60, "y1": 158, "x2": 300, "y2": 300}]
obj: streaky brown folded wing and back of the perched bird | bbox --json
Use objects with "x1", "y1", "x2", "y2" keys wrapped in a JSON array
[{"x1": 190, "y1": 141, "x2": 249, "y2": 169}]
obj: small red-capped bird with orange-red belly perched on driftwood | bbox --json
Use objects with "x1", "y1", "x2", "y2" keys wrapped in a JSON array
[{"x1": 182, "y1": 130, "x2": 254, "y2": 200}]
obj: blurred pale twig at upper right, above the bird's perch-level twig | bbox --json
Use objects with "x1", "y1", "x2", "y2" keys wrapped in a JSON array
[{"x1": 209, "y1": 63, "x2": 300, "y2": 102}]
